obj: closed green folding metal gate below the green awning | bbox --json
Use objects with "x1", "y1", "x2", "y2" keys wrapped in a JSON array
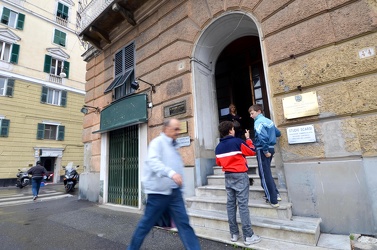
[{"x1": 107, "y1": 125, "x2": 139, "y2": 207}]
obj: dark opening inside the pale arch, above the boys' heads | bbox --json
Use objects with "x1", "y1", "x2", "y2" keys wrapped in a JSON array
[{"x1": 215, "y1": 36, "x2": 270, "y2": 137}]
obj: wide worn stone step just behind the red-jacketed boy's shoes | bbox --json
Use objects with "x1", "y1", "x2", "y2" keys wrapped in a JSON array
[{"x1": 187, "y1": 208, "x2": 321, "y2": 246}]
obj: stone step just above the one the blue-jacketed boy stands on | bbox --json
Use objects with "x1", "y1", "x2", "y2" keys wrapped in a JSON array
[{"x1": 195, "y1": 185, "x2": 288, "y2": 201}]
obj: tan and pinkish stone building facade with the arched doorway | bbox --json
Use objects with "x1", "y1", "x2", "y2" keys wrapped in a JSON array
[{"x1": 80, "y1": 0, "x2": 377, "y2": 234}]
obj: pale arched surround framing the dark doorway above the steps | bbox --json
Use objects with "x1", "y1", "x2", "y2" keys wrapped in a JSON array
[{"x1": 191, "y1": 11, "x2": 269, "y2": 186}]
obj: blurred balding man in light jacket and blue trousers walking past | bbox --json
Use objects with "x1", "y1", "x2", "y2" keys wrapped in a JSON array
[{"x1": 127, "y1": 119, "x2": 201, "y2": 250}]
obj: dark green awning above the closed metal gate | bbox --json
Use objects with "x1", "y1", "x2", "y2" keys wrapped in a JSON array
[{"x1": 93, "y1": 94, "x2": 148, "y2": 134}]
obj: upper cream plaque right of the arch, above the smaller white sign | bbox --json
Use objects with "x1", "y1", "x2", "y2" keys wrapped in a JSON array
[{"x1": 283, "y1": 91, "x2": 319, "y2": 119}]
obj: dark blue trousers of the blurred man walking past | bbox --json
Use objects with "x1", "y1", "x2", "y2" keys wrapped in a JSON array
[{"x1": 127, "y1": 189, "x2": 201, "y2": 250}]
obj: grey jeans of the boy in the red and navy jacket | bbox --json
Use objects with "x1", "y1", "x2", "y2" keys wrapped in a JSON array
[{"x1": 225, "y1": 173, "x2": 254, "y2": 239}]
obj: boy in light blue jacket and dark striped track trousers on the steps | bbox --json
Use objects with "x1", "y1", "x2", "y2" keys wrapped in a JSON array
[{"x1": 249, "y1": 104, "x2": 281, "y2": 208}]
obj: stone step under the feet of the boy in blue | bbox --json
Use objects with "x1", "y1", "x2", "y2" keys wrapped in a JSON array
[{"x1": 186, "y1": 196, "x2": 292, "y2": 220}]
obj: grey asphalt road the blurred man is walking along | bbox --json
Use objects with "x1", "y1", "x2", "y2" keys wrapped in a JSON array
[{"x1": 0, "y1": 185, "x2": 233, "y2": 250}]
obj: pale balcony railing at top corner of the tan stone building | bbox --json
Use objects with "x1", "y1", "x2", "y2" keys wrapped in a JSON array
[{"x1": 77, "y1": 0, "x2": 114, "y2": 33}]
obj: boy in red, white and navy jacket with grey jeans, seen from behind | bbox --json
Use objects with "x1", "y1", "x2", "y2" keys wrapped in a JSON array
[{"x1": 215, "y1": 121, "x2": 261, "y2": 245}]
